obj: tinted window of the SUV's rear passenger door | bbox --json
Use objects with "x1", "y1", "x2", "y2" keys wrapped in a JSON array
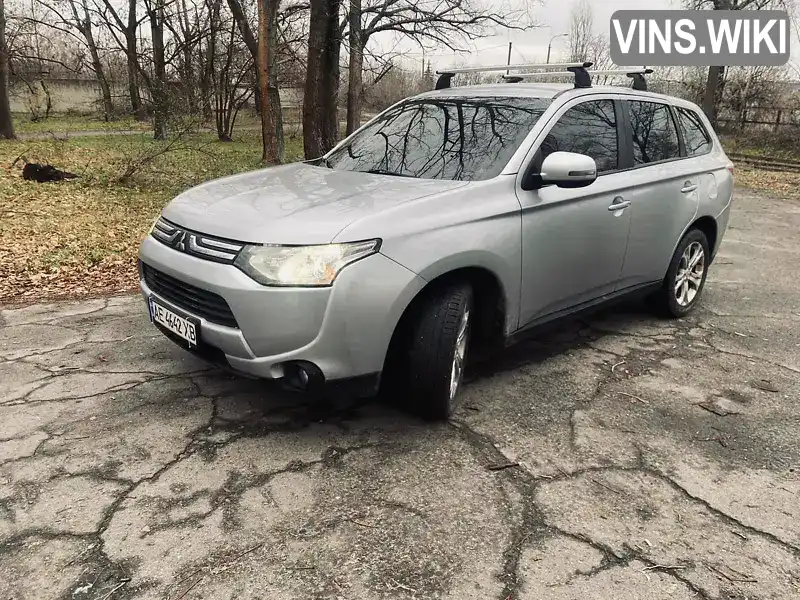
[{"x1": 628, "y1": 100, "x2": 681, "y2": 166}]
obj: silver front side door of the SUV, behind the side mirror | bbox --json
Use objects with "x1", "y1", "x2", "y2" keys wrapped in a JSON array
[{"x1": 517, "y1": 95, "x2": 630, "y2": 327}]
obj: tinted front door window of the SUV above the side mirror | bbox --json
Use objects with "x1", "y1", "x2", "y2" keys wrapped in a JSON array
[{"x1": 537, "y1": 100, "x2": 619, "y2": 174}]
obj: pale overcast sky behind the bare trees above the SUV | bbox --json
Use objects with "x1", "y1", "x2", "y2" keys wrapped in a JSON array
[{"x1": 388, "y1": 0, "x2": 800, "y2": 76}]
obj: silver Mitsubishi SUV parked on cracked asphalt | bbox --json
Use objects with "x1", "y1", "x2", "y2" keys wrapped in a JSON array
[{"x1": 139, "y1": 70, "x2": 733, "y2": 418}]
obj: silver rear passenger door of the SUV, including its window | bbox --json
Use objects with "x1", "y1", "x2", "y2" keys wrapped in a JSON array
[{"x1": 618, "y1": 98, "x2": 703, "y2": 290}]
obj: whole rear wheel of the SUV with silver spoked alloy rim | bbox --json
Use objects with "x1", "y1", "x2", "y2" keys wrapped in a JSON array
[{"x1": 657, "y1": 229, "x2": 711, "y2": 318}]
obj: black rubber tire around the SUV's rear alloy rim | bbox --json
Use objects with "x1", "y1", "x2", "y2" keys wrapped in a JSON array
[{"x1": 654, "y1": 229, "x2": 711, "y2": 319}]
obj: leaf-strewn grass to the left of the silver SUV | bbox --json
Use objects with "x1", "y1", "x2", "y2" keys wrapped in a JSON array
[{"x1": 0, "y1": 134, "x2": 301, "y2": 303}]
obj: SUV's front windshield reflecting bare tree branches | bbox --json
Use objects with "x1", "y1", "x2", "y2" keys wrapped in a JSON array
[{"x1": 325, "y1": 97, "x2": 551, "y2": 181}]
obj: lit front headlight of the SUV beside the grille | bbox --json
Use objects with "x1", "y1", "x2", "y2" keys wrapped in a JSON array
[{"x1": 234, "y1": 240, "x2": 380, "y2": 286}]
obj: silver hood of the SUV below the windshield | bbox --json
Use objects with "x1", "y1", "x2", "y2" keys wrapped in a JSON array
[{"x1": 163, "y1": 163, "x2": 466, "y2": 244}]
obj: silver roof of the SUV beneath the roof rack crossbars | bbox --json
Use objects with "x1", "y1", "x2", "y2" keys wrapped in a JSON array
[{"x1": 415, "y1": 82, "x2": 697, "y2": 110}]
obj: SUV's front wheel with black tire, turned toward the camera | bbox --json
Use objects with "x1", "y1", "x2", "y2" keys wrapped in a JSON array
[{"x1": 404, "y1": 283, "x2": 473, "y2": 420}]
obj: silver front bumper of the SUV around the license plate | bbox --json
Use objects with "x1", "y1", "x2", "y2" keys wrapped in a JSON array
[{"x1": 139, "y1": 236, "x2": 425, "y2": 381}]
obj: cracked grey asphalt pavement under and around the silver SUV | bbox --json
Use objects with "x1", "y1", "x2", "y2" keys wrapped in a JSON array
[{"x1": 0, "y1": 192, "x2": 800, "y2": 600}]
